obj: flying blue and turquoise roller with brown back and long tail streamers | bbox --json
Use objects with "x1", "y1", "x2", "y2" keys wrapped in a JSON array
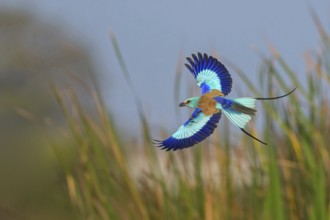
[{"x1": 155, "y1": 53, "x2": 295, "y2": 150}]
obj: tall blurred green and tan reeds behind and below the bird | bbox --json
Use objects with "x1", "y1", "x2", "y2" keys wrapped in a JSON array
[{"x1": 53, "y1": 20, "x2": 330, "y2": 220}]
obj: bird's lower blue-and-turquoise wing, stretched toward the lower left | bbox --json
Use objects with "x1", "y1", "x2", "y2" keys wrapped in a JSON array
[{"x1": 154, "y1": 108, "x2": 221, "y2": 151}]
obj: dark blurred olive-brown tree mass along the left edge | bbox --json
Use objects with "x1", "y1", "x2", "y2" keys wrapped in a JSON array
[{"x1": 0, "y1": 11, "x2": 95, "y2": 218}]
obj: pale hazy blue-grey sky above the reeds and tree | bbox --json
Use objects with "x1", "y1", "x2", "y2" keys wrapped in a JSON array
[{"x1": 0, "y1": 0, "x2": 330, "y2": 138}]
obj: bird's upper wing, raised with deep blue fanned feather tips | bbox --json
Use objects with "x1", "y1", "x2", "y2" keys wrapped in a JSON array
[{"x1": 185, "y1": 53, "x2": 233, "y2": 95}]
